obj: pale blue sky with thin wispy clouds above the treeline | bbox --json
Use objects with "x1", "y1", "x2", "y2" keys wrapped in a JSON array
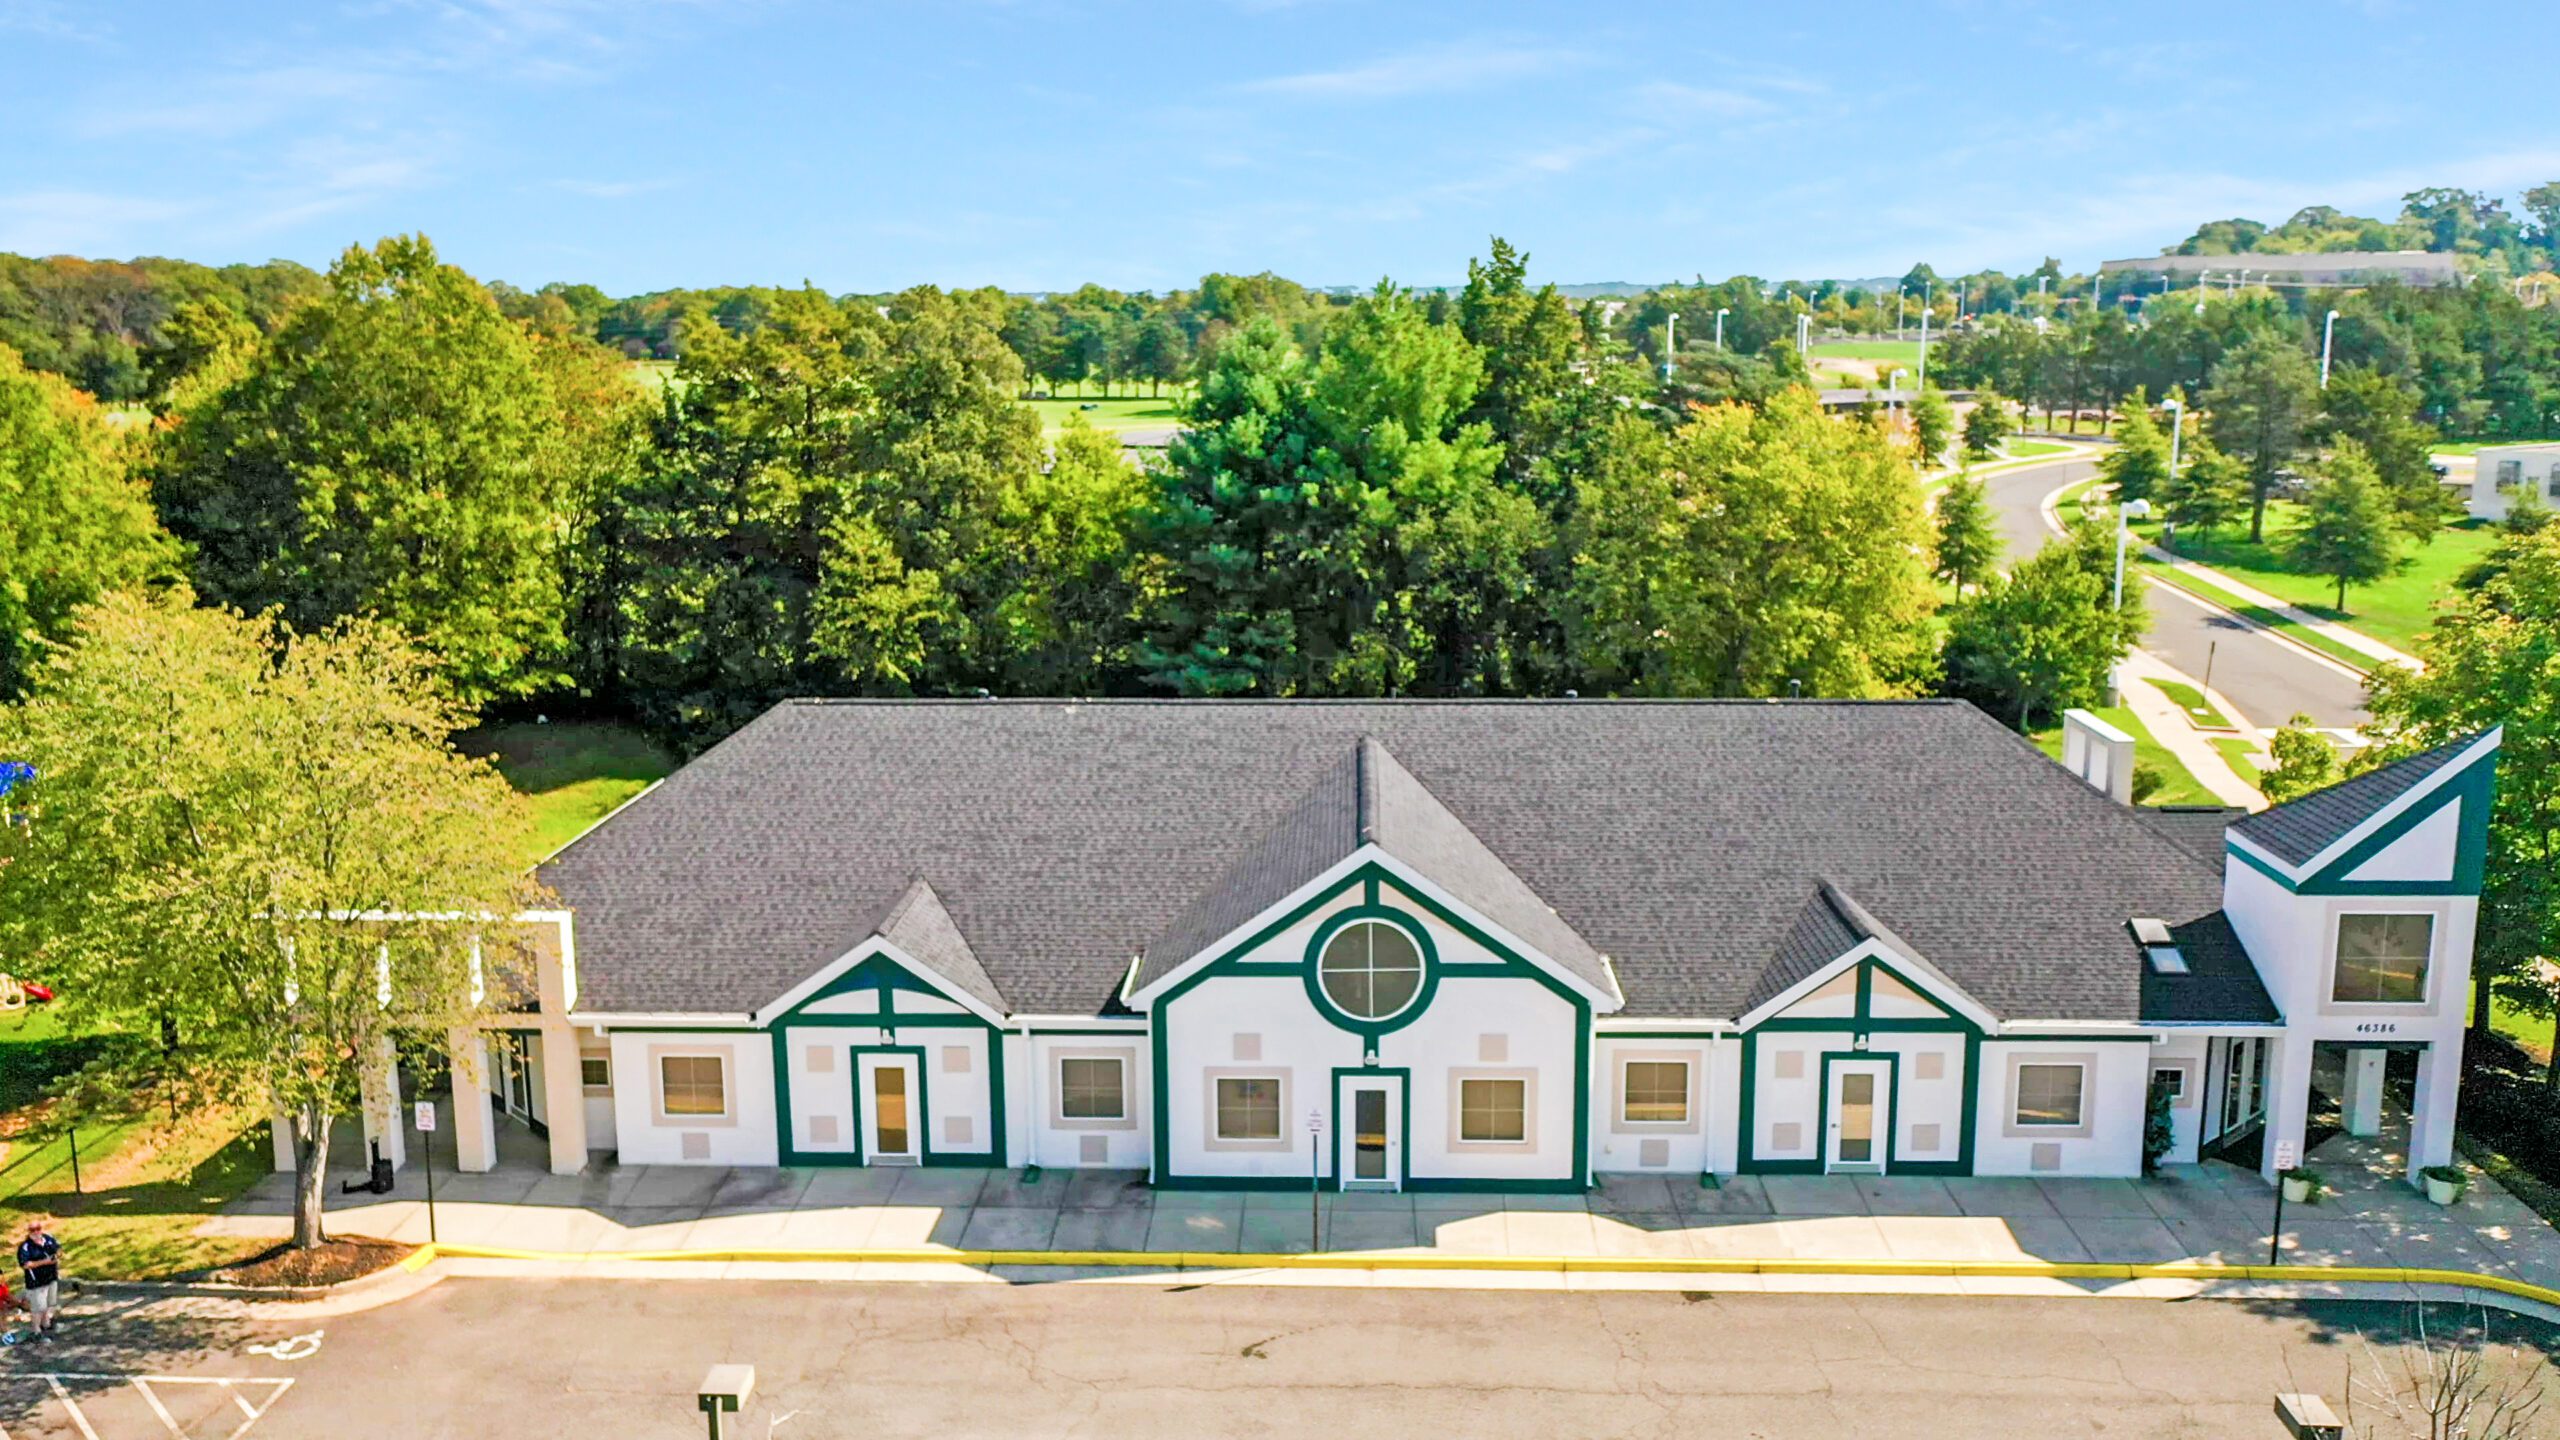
[{"x1": 0, "y1": 0, "x2": 2560, "y2": 292}]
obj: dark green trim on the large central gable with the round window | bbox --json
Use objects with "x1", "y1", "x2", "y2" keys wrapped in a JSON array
[{"x1": 1147, "y1": 861, "x2": 1592, "y2": 1189}]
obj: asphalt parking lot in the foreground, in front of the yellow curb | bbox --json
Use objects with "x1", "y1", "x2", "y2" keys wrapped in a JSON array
[{"x1": 0, "y1": 1279, "x2": 2560, "y2": 1440}]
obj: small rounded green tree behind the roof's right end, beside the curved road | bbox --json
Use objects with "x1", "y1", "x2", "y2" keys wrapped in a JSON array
[{"x1": 1946, "y1": 541, "x2": 2130, "y2": 730}]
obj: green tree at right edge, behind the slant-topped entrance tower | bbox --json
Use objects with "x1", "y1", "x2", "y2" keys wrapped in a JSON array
[{"x1": 2365, "y1": 525, "x2": 2560, "y2": 1055}]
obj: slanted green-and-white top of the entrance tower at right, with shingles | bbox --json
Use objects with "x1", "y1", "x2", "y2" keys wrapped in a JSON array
[{"x1": 2227, "y1": 728, "x2": 2504, "y2": 894}]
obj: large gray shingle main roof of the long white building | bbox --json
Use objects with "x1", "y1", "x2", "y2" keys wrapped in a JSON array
[{"x1": 543, "y1": 700, "x2": 2263, "y2": 1020}]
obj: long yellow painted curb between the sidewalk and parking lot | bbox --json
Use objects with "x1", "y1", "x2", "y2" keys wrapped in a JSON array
[{"x1": 402, "y1": 1245, "x2": 2560, "y2": 1307}]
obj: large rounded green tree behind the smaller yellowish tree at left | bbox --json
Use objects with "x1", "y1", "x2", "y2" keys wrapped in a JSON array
[{"x1": 154, "y1": 236, "x2": 599, "y2": 705}]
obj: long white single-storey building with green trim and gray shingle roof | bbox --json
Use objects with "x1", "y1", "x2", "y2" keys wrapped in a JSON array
[{"x1": 409, "y1": 700, "x2": 2499, "y2": 1191}]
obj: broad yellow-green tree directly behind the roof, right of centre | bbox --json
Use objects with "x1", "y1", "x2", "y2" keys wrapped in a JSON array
[{"x1": 1569, "y1": 389, "x2": 1935, "y2": 697}]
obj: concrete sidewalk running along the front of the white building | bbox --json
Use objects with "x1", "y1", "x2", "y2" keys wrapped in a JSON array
[{"x1": 205, "y1": 1138, "x2": 2560, "y2": 1294}]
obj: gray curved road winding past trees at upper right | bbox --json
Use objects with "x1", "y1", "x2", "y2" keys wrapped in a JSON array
[{"x1": 1984, "y1": 459, "x2": 2365, "y2": 730}]
